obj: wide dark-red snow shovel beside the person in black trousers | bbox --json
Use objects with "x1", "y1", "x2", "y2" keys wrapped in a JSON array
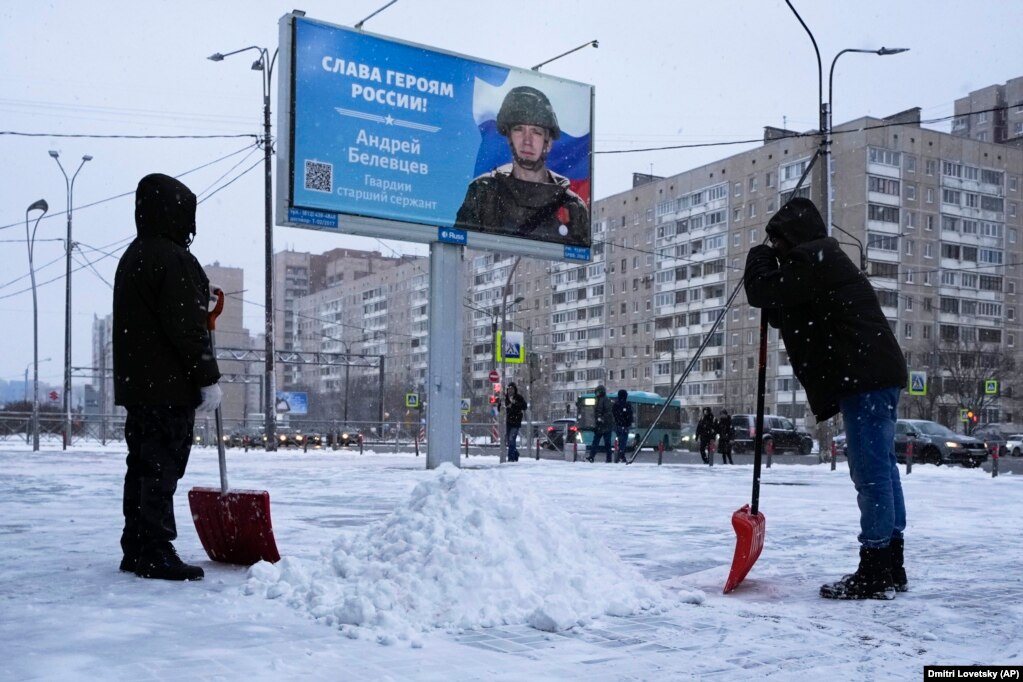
[{"x1": 188, "y1": 289, "x2": 280, "y2": 565}]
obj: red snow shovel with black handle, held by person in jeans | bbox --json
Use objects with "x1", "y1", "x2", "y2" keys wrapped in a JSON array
[{"x1": 724, "y1": 309, "x2": 767, "y2": 594}]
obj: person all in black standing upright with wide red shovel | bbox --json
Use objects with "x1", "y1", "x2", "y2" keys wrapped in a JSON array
[{"x1": 112, "y1": 174, "x2": 222, "y2": 580}]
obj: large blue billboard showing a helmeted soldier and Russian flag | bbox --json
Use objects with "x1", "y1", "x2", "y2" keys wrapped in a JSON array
[{"x1": 276, "y1": 14, "x2": 593, "y2": 261}]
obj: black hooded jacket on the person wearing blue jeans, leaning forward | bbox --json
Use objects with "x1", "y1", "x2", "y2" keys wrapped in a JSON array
[{"x1": 745, "y1": 198, "x2": 907, "y2": 421}]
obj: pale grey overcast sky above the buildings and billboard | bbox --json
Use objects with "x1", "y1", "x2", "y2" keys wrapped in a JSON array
[{"x1": 0, "y1": 0, "x2": 1023, "y2": 394}]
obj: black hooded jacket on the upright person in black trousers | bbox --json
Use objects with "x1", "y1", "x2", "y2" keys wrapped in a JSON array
[{"x1": 113, "y1": 174, "x2": 220, "y2": 407}]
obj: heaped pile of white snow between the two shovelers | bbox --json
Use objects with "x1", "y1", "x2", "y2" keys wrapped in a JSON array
[{"x1": 246, "y1": 464, "x2": 704, "y2": 646}]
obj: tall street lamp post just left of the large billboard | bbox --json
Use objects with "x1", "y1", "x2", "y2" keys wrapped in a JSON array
[{"x1": 208, "y1": 45, "x2": 277, "y2": 450}]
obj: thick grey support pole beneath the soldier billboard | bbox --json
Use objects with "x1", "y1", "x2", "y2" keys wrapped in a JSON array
[{"x1": 426, "y1": 241, "x2": 463, "y2": 469}]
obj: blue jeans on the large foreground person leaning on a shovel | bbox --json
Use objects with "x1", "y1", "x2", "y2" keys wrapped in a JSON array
[{"x1": 839, "y1": 389, "x2": 905, "y2": 549}]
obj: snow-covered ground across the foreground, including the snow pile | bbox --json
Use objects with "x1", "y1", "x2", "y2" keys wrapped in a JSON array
[{"x1": 0, "y1": 442, "x2": 1023, "y2": 681}]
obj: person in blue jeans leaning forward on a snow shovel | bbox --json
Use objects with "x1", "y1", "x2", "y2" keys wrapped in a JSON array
[{"x1": 744, "y1": 197, "x2": 908, "y2": 599}]
